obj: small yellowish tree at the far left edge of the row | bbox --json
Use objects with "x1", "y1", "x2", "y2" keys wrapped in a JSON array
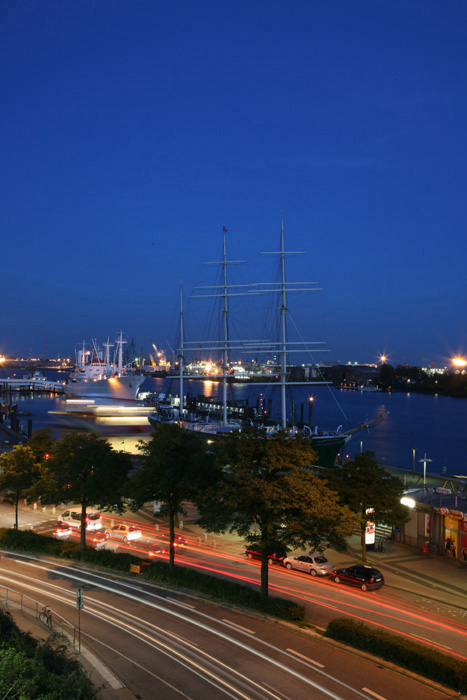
[{"x1": 0, "y1": 445, "x2": 40, "y2": 529}]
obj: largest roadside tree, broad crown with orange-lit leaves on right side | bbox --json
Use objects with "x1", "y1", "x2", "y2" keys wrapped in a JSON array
[{"x1": 196, "y1": 431, "x2": 355, "y2": 597}]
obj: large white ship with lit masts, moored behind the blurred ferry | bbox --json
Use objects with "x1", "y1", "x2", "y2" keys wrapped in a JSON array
[{"x1": 63, "y1": 332, "x2": 145, "y2": 401}]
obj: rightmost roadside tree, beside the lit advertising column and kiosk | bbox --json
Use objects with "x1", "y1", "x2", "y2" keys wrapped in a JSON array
[{"x1": 322, "y1": 451, "x2": 410, "y2": 561}]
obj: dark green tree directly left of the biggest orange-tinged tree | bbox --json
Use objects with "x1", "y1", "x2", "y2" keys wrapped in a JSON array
[{"x1": 130, "y1": 424, "x2": 212, "y2": 570}]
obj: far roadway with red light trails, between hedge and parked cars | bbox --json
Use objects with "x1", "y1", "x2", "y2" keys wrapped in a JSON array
[{"x1": 0, "y1": 506, "x2": 467, "y2": 672}]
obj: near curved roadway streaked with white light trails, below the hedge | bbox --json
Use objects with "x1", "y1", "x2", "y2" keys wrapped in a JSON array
[{"x1": 0, "y1": 554, "x2": 454, "y2": 700}]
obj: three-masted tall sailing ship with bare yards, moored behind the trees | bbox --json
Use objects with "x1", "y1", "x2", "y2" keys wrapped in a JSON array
[{"x1": 148, "y1": 221, "x2": 381, "y2": 468}]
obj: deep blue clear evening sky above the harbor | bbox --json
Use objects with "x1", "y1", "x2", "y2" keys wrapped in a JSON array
[{"x1": 0, "y1": 0, "x2": 467, "y2": 365}]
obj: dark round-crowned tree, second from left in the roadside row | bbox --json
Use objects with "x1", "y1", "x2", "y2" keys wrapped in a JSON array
[{"x1": 36, "y1": 433, "x2": 132, "y2": 549}]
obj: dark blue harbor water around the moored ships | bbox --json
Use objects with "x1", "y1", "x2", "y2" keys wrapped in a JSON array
[{"x1": 0, "y1": 369, "x2": 467, "y2": 477}]
